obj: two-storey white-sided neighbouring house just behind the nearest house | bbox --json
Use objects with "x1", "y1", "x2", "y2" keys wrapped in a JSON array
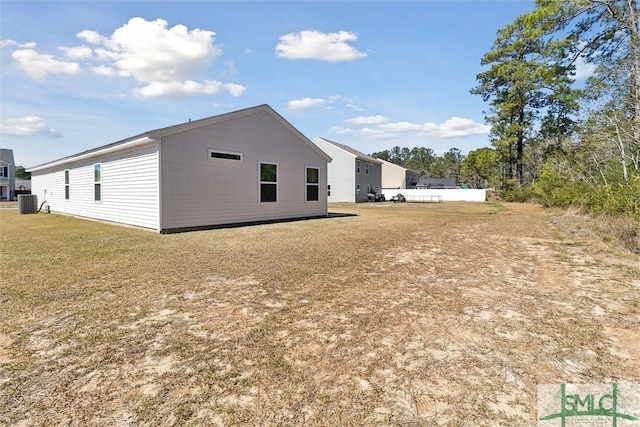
[{"x1": 311, "y1": 137, "x2": 382, "y2": 202}]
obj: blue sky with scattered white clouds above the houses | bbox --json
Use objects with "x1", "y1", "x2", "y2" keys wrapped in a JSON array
[{"x1": 0, "y1": 0, "x2": 552, "y2": 167}]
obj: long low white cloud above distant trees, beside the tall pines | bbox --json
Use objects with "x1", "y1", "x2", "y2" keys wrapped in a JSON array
[{"x1": 379, "y1": 117, "x2": 491, "y2": 138}]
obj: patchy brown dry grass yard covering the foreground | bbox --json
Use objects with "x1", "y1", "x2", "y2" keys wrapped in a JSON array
[{"x1": 0, "y1": 203, "x2": 640, "y2": 426}]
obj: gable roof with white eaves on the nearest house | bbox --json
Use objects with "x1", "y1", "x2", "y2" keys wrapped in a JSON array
[{"x1": 28, "y1": 104, "x2": 331, "y2": 172}]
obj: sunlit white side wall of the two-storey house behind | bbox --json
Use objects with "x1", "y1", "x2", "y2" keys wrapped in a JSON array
[{"x1": 311, "y1": 137, "x2": 356, "y2": 203}]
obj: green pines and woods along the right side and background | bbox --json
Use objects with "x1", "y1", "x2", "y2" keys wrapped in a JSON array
[{"x1": 374, "y1": 0, "x2": 640, "y2": 221}]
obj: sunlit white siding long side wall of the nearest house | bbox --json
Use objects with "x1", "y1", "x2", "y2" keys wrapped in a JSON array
[{"x1": 31, "y1": 143, "x2": 159, "y2": 230}]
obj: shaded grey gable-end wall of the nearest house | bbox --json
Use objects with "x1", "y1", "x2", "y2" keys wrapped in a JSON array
[{"x1": 160, "y1": 112, "x2": 328, "y2": 230}]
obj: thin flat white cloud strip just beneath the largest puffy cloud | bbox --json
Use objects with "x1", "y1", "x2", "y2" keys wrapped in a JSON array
[{"x1": 135, "y1": 80, "x2": 246, "y2": 98}]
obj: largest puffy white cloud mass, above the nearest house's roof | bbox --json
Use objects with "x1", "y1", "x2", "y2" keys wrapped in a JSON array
[{"x1": 64, "y1": 17, "x2": 246, "y2": 98}]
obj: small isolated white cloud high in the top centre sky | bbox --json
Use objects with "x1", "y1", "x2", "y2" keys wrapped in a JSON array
[{"x1": 276, "y1": 30, "x2": 367, "y2": 62}]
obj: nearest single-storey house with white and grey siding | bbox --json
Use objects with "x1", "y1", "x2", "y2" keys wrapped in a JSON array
[{"x1": 29, "y1": 105, "x2": 331, "y2": 233}]
